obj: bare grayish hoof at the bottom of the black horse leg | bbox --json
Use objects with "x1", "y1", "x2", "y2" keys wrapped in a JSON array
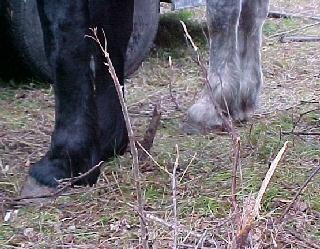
[{"x1": 20, "y1": 176, "x2": 57, "y2": 203}]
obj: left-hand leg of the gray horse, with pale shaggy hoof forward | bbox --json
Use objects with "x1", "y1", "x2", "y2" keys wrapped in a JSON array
[{"x1": 182, "y1": 0, "x2": 241, "y2": 133}]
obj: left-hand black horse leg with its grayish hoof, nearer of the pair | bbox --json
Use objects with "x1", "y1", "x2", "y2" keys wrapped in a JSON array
[{"x1": 22, "y1": 0, "x2": 100, "y2": 195}]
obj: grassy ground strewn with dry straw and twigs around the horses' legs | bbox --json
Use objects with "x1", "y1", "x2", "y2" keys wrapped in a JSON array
[{"x1": 0, "y1": 0, "x2": 320, "y2": 248}]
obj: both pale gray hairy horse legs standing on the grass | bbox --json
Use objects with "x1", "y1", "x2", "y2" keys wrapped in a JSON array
[{"x1": 183, "y1": 0, "x2": 269, "y2": 133}]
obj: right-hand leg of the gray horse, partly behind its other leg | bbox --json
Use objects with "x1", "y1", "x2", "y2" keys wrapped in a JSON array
[{"x1": 233, "y1": 0, "x2": 269, "y2": 120}]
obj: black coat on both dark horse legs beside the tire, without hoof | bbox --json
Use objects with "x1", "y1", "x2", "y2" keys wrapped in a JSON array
[{"x1": 24, "y1": 0, "x2": 134, "y2": 191}]
